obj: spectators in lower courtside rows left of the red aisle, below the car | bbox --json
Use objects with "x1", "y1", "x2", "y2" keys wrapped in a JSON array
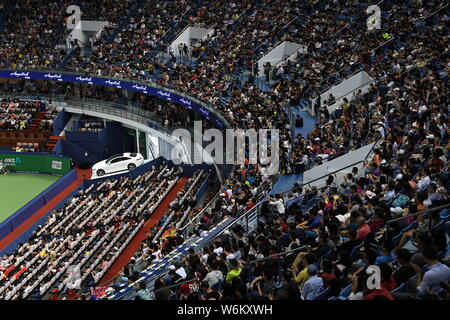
[{"x1": 0, "y1": 163, "x2": 193, "y2": 300}]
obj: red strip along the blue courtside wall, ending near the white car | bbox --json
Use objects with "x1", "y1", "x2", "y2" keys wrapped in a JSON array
[{"x1": 0, "y1": 168, "x2": 92, "y2": 251}]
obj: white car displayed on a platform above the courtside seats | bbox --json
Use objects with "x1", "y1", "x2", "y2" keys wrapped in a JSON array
[{"x1": 92, "y1": 152, "x2": 144, "y2": 177}]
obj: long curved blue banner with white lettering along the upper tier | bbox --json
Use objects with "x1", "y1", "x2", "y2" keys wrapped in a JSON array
[{"x1": 0, "y1": 70, "x2": 224, "y2": 129}]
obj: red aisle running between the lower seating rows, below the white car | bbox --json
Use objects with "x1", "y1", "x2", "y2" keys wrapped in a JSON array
[{"x1": 99, "y1": 177, "x2": 188, "y2": 284}]
